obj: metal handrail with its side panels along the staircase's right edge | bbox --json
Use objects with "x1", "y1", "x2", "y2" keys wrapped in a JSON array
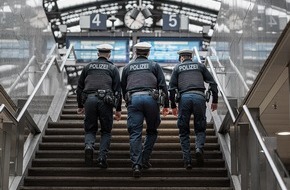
[{"x1": 206, "y1": 53, "x2": 290, "y2": 190}]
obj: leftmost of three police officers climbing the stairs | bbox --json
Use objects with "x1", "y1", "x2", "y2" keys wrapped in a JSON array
[{"x1": 76, "y1": 44, "x2": 122, "y2": 168}]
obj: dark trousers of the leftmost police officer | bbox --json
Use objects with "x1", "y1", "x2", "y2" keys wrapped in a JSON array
[{"x1": 84, "y1": 94, "x2": 113, "y2": 159}]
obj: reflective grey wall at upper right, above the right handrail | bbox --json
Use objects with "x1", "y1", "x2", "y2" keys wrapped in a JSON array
[{"x1": 210, "y1": 0, "x2": 290, "y2": 96}]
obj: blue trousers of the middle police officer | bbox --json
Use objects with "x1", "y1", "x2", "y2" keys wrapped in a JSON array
[{"x1": 127, "y1": 93, "x2": 161, "y2": 167}]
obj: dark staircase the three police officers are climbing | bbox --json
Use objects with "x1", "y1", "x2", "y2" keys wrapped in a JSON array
[{"x1": 20, "y1": 95, "x2": 233, "y2": 190}]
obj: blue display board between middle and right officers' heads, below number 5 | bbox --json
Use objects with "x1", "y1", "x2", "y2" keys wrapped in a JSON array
[{"x1": 140, "y1": 37, "x2": 202, "y2": 63}]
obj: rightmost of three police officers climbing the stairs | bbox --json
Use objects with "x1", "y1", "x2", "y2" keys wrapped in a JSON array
[{"x1": 169, "y1": 49, "x2": 218, "y2": 169}]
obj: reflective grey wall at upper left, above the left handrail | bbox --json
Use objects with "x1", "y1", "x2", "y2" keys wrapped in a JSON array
[{"x1": 0, "y1": 0, "x2": 55, "y2": 95}]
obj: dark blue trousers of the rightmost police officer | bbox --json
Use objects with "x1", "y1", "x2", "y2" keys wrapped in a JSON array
[{"x1": 177, "y1": 92, "x2": 206, "y2": 161}]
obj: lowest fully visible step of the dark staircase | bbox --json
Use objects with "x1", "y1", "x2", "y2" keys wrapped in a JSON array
[{"x1": 24, "y1": 176, "x2": 230, "y2": 187}]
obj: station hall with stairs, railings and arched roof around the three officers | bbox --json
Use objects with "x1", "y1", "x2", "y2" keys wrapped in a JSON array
[{"x1": 0, "y1": 0, "x2": 290, "y2": 190}]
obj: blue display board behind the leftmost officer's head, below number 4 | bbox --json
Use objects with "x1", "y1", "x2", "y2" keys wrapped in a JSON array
[{"x1": 67, "y1": 36, "x2": 129, "y2": 63}]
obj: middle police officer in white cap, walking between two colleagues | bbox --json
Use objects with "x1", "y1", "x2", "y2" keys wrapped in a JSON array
[{"x1": 121, "y1": 42, "x2": 169, "y2": 177}]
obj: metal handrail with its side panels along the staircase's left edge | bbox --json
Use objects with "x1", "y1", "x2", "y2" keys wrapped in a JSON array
[{"x1": 0, "y1": 45, "x2": 75, "y2": 190}]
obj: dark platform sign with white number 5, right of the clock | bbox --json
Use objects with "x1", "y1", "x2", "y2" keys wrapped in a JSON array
[{"x1": 162, "y1": 14, "x2": 180, "y2": 31}]
